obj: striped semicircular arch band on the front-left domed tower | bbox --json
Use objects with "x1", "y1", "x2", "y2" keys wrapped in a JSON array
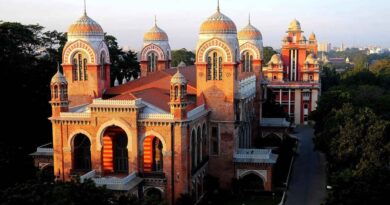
[{"x1": 62, "y1": 40, "x2": 97, "y2": 65}]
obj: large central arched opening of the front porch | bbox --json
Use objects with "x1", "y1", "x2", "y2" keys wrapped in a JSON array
[{"x1": 102, "y1": 126, "x2": 129, "y2": 174}]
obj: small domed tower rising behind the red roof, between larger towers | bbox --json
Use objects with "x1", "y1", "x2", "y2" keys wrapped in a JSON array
[{"x1": 141, "y1": 17, "x2": 171, "y2": 77}]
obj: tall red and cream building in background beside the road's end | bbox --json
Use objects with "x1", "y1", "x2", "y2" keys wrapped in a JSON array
[{"x1": 263, "y1": 20, "x2": 321, "y2": 124}]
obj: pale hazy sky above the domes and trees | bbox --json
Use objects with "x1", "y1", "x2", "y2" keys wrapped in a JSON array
[{"x1": 0, "y1": 0, "x2": 390, "y2": 51}]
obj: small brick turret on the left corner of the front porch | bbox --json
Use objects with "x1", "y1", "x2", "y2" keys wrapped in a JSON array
[{"x1": 50, "y1": 65, "x2": 69, "y2": 117}]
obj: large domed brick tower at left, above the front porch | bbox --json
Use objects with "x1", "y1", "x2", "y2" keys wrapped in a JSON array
[{"x1": 62, "y1": 2, "x2": 110, "y2": 107}]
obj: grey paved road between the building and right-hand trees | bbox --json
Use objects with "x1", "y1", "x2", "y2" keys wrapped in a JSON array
[{"x1": 286, "y1": 126, "x2": 326, "y2": 205}]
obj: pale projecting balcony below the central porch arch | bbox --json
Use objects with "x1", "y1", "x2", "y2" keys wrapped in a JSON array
[{"x1": 80, "y1": 170, "x2": 142, "y2": 191}]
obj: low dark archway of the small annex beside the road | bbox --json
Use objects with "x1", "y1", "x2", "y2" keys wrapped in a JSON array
[{"x1": 239, "y1": 173, "x2": 264, "y2": 193}]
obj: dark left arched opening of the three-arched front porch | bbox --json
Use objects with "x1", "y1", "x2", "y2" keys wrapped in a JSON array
[{"x1": 73, "y1": 134, "x2": 92, "y2": 173}]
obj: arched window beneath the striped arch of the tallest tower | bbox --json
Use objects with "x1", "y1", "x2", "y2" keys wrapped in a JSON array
[{"x1": 207, "y1": 51, "x2": 223, "y2": 80}]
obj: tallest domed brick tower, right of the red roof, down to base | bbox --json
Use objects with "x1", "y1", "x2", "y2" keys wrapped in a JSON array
[{"x1": 196, "y1": 0, "x2": 240, "y2": 188}]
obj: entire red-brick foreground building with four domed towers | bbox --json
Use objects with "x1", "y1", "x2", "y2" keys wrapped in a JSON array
[{"x1": 45, "y1": 2, "x2": 278, "y2": 203}]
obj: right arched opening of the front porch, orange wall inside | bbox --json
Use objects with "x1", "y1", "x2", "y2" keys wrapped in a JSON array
[{"x1": 144, "y1": 136, "x2": 164, "y2": 172}]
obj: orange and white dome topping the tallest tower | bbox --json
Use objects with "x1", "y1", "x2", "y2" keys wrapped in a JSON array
[{"x1": 199, "y1": 10, "x2": 237, "y2": 34}]
